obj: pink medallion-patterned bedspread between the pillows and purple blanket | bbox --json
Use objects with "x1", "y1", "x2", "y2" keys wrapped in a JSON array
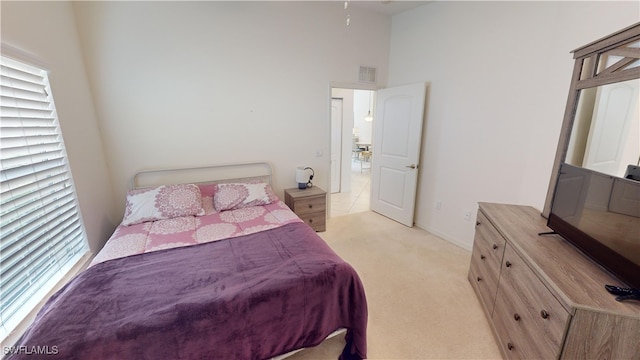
[{"x1": 89, "y1": 187, "x2": 302, "y2": 266}]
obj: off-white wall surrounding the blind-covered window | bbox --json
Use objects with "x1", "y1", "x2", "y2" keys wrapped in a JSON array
[{"x1": 1, "y1": 1, "x2": 120, "y2": 251}]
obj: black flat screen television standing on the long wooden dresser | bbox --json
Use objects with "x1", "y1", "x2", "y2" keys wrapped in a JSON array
[{"x1": 547, "y1": 164, "x2": 640, "y2": 288}]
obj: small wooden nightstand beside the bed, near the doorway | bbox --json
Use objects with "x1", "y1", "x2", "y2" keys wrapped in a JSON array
[{"x1": 284, "y1": 186, "x2": 327, "y2": 231}]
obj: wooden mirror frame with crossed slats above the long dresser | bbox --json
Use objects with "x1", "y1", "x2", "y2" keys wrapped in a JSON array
[{"x1": 542, "y1": 23, "x2": 640, "y2": 218}]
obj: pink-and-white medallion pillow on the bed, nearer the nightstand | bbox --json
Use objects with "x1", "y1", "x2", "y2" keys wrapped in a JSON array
[{"x1": 213, "y1": 183, "x2": 278, "y2": 211}]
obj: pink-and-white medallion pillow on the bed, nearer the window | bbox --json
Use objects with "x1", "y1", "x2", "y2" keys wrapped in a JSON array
[{"x1": 122, "y1": 184, "x2": 204, "y2": 225}]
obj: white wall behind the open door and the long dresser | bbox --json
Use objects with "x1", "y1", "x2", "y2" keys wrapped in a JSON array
[{"x1": 389, "y1": 1, "x2": 640, "y2": 249}]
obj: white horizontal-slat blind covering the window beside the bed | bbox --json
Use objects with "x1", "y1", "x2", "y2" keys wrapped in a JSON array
[{"x1": 0, "y1": 57, "x2": 88, "y2": 337}]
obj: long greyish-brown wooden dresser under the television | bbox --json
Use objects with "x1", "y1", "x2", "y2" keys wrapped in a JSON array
[{"x1": 468, "y1": 203, "x2": 640, "y2": 359}]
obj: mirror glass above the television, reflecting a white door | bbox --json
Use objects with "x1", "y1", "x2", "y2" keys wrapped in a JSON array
[{"x1": 565, "y1": 79, "x2": 640, "y2": 177}]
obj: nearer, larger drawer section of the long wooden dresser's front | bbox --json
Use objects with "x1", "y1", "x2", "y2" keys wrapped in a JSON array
[{"x1": 493, "y1": 245, "x2": 570, "y2": 359}]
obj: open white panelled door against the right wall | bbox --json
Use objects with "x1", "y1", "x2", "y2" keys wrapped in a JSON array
[{"x1": 370, "y1": 83, "x2": 427, "y2": 226}]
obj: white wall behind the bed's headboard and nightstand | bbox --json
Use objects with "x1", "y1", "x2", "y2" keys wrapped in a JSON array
[{"x1": 73, "y1": 2, "x2": 391, "y2": 212}]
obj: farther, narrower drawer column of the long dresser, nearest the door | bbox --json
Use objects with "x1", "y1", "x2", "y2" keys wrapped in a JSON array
[{"x1": 468, "y1": 211, "x2": 506, "y2": 318}]
